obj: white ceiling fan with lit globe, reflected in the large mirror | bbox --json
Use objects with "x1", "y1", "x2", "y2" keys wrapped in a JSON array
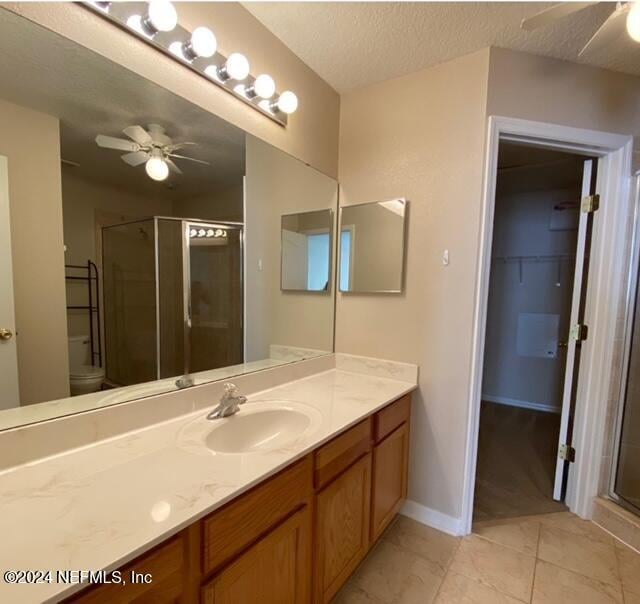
[{"x1": 96, "y1": 124, "x2": 210, "y2": 180}]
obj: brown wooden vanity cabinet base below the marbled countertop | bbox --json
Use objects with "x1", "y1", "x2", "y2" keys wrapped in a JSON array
[{"x1": 68, "y1": 394, "x2": 411, "y2": 604}]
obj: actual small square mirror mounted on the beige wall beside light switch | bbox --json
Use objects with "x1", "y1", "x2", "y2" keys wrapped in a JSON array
[{"x1": 339, "y1": 199, "x2": 408, "y2": 293}]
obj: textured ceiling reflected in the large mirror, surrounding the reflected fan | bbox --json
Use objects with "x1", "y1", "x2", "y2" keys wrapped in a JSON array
[{"x1": 0, "y1": 9, "x2": 245, "y2": 201}]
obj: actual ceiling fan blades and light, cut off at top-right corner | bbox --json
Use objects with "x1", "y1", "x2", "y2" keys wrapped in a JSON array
[{"x1": 520, "y1": 2, "x2": 640, "y2": 56}]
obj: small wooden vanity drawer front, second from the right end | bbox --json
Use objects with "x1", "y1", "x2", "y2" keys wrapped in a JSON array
[{"x1": 314, "y1": 417, "x2": 372, "y2": 489}]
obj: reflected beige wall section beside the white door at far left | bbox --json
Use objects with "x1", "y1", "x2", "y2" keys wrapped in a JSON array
[{"x1": 0, "y1": 100, "x2": 69, "y2": 405}]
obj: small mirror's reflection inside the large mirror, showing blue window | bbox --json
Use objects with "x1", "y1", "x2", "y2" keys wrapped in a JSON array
[{"x1": 281, "y1": 210, "x2": 333, "y2": 292}]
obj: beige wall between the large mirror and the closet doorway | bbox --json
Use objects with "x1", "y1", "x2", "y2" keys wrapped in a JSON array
[{"x1": 336, "y1": 50, "x2": 489, "y2": 516}]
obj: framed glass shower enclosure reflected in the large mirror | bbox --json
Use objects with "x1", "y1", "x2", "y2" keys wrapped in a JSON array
[{"x1": 102, "y1": 217, "x2": 244, "y2": 386}]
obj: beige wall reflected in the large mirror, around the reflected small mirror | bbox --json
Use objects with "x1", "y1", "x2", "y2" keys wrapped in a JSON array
[{"x1": 245, "y1": 136, "x2": 338, "y2": 361}]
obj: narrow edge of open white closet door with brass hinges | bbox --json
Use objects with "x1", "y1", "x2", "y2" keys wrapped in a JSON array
[{"x1": 553, "y1": 159, "x2": 597, "y2": 501}]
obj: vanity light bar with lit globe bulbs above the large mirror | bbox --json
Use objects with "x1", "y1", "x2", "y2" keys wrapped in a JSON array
[{"x1": 83, "y1": 0, "x2": 298, "y2": 126}]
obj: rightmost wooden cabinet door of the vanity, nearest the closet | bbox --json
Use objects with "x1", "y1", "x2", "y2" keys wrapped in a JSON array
[{"x1": 371, "y1": 424, "x2": 409, "y2": 541}]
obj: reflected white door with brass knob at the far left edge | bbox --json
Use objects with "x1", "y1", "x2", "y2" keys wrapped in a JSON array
[{"x1": 0, "y1": 156, "x2": 20, "y2": 409}]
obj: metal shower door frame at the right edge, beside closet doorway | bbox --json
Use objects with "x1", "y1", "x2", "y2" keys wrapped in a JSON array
[{"x1": 608, "y1": 171, "x2": 640, "y2": 514}]
